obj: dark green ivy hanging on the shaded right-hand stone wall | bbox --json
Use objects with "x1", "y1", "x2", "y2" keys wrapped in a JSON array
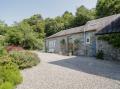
[{"x1": 98, "y1": 33, "x2": 120, "y2": 48}]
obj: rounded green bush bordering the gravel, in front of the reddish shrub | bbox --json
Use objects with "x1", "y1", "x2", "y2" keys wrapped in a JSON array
[{"x1": 10, "y1": 51, "x2": 40, "y2": 69}]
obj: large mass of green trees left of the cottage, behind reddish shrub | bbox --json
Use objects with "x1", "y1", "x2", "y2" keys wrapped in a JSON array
[{"x1": 6, "y1": 15, "x2": 45, "y2": 49}]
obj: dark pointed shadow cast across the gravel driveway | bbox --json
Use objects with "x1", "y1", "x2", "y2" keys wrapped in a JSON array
[{"x1": 49, "y1": 57, "x2": 120, "y2": 80}]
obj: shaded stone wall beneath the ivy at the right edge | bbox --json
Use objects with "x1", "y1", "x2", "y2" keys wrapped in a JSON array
[{"x1": 97, "y1": 40, "x2": 120, "y2": 61}]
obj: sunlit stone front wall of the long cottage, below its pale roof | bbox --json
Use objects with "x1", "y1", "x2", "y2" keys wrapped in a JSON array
[{"x1": 46, "y1": 31, "x2": 96, "y2": 56}]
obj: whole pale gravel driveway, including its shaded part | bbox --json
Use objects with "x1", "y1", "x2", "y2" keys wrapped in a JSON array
[{"x1": 17, "y1": 52, "x2": 120, "y2": 89}]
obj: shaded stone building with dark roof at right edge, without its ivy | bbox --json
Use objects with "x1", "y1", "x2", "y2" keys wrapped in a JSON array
[{"x1": 96, "y1": 17, "x2": 120, "y2": 60}]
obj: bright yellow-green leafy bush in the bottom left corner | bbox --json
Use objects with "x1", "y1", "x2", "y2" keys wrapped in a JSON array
[{"x1": 0, "y1": 56, "x2": 22, "y2": 89}]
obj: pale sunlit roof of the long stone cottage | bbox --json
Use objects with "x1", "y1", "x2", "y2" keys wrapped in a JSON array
[{"x1": 47, "y1": 14, "x2": 120, "y2": 38}]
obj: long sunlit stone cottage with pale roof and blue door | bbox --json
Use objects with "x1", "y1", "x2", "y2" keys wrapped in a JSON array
[{"x1": 46, "y1": 14, "x2": 120, "y2": 56}]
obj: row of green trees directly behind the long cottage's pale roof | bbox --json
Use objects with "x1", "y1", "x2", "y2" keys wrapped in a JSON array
[{"x1": 45, "y1": 6, "x2": 96, "y2": 37}]
